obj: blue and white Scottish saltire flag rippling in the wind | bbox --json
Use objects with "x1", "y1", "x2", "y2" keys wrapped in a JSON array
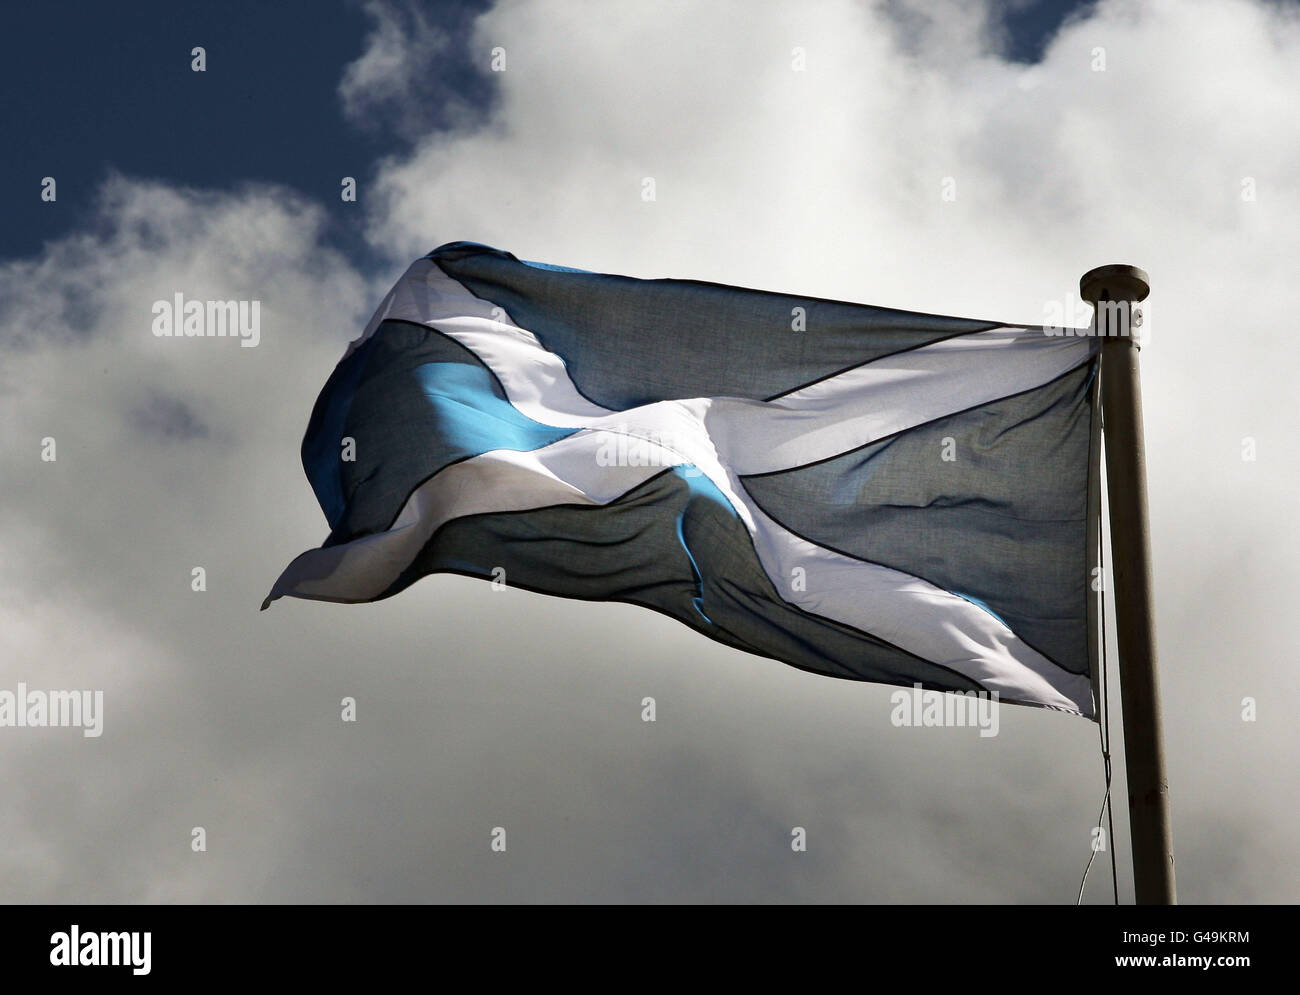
[{"x1": 263, "y1": 242, "x2": 1097, "y2": 715}]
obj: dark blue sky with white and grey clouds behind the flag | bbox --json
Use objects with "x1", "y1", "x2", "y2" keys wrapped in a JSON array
[{"x1": 0, "y1": 0, "x2": 1300, "y2": 903}]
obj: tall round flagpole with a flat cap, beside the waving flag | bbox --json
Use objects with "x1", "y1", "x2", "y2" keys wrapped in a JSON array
[{"x1": 1079, "y1": 265, "x2": 1177, "y2": 905}]
